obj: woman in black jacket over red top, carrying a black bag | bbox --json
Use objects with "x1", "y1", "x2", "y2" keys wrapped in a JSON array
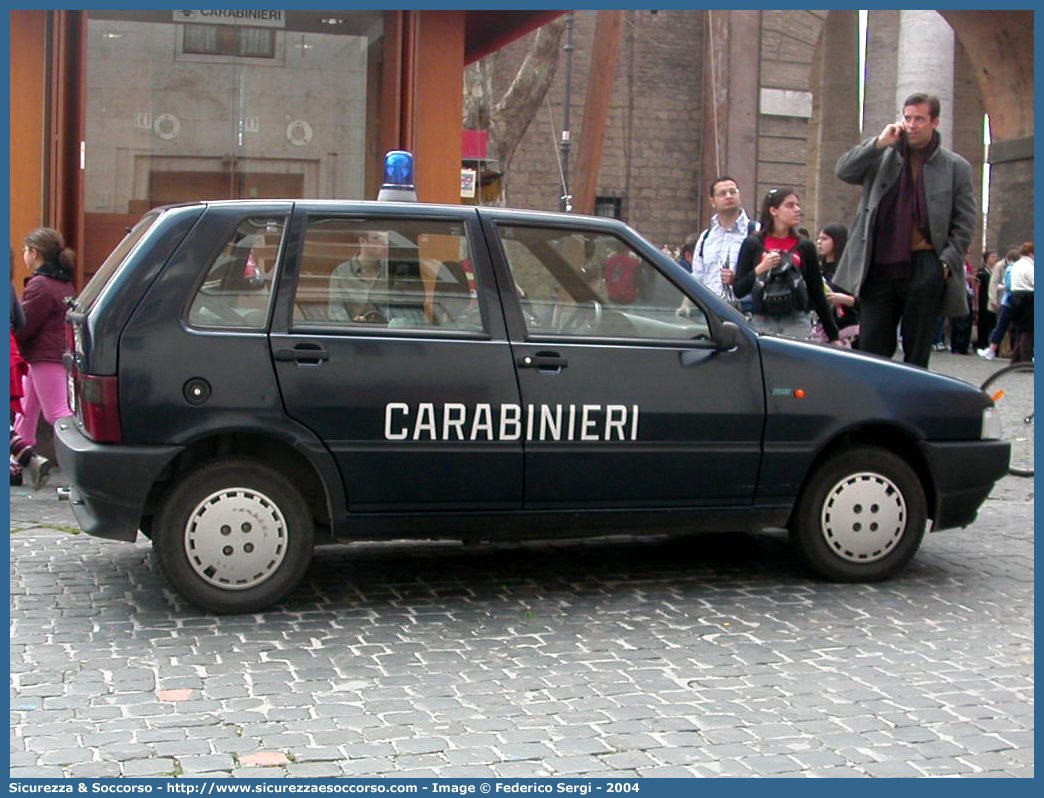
[{"x1": 733, "y1": 187, "x2": 838, "y2": 344}]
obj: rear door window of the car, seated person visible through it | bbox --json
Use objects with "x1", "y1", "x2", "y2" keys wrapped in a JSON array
[{"x1": 293, "y1": 216, "x2": 483, "y2": 332}]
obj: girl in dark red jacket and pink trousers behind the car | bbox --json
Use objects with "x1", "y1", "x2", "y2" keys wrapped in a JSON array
[{"x1": 15, "y1": 228, "x2": 76, "y2": 446}]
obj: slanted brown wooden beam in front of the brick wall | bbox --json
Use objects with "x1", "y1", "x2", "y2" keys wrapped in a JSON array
[{"x1": 573, "y1": 10, "x2": 623, "y2": 213}]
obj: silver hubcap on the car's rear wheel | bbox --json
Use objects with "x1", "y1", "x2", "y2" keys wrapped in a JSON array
[{"x1": 185, "y1": 488, "x2": 287, "y2": 590}]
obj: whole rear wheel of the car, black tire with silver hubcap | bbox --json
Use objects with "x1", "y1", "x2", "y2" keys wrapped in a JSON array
[{"x1": 152, "y1": 459, "x2": 313, "y2": 613}]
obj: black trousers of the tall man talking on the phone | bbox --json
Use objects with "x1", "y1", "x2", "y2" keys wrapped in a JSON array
[{"x1": 859, "y1": 250, "x2": 946, "y2": 368}]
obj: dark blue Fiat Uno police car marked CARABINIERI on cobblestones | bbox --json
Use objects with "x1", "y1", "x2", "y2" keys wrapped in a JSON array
[{"x1": 56, "y1": 192, "x2": 1009, "y2": 612}]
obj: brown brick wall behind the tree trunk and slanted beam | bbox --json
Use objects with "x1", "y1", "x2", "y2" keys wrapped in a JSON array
[{"x1": 494, "y1": 10, "x2": 704, "y2": 244}]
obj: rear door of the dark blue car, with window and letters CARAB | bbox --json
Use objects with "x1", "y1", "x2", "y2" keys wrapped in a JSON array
[{"x1": 270, "y1": 204, "x2": 522, "y2": 512}]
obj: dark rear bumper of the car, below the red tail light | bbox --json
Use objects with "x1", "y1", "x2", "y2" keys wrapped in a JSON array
[{"x1": 54, "y1": 418, "x2": 183, "y2": 541}]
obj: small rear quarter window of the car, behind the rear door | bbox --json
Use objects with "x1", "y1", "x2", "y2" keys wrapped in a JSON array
[{"x1": 189, "y1": 216, "x2": 286, "y2": 330}]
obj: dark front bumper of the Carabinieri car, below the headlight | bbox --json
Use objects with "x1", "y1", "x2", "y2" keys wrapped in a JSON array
[{"x1": 921, "y1": 441, "x2": 1012, "y2": 532}]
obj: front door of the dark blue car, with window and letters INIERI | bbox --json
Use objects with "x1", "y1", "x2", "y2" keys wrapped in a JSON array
[{"x1": 485, "y1": 212, "x2": 765, "y2": 509}]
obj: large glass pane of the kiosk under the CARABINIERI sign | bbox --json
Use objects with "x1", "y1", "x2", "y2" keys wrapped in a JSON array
[{"x1": 82, "y1": 9, "x2": 383, "y2": 275}]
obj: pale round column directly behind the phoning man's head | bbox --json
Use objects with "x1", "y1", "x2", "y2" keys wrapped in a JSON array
[{"x1": 895, "y1": 10, "x2": 953, "y2": 148}]
